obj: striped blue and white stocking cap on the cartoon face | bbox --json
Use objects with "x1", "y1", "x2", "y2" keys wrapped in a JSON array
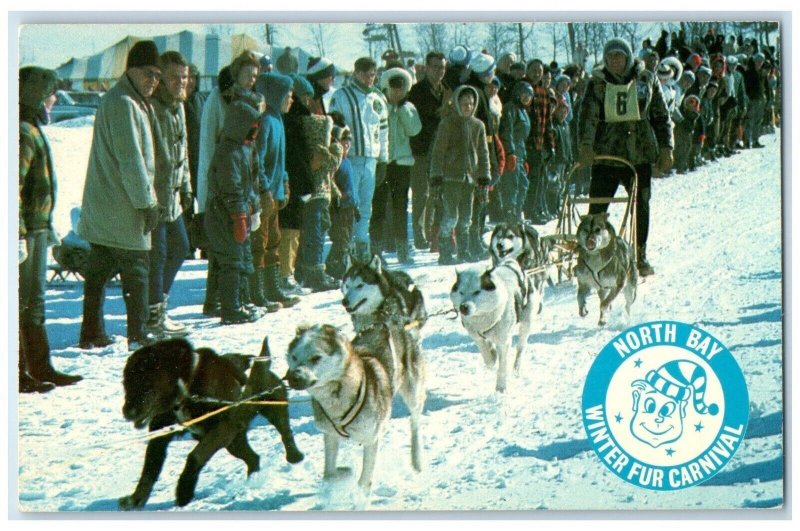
[{"x1": 645, "y1": 360, "x2": 719, "y2": 415}]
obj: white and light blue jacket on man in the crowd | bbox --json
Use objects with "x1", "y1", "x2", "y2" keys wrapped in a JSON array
[{"x1": 328, "y1": 81, "x2": 389, "y2": 162}]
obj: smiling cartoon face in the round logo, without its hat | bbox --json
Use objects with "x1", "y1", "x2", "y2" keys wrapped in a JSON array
[{"x1": 631, "y1": 380, "x2": 686, "y2": 448}]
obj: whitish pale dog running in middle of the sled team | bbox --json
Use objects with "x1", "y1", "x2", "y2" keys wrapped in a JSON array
[{"x1": 450, "y1": 259, "x2": 541, "y2": 392}]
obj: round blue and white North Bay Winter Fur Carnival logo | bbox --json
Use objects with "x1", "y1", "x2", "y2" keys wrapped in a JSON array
[{"x1": 583, "y1": 321, "x2": 750, "y2": 490}]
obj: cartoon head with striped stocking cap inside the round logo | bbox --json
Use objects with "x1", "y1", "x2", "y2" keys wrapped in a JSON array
[{"x1": 630, "y1": 360, "x2": 719, "y2": 448}]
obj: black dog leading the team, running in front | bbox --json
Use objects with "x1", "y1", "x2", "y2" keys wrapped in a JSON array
[{"x1": 119, "y1": 338, "x2": 303, "y2": 510}]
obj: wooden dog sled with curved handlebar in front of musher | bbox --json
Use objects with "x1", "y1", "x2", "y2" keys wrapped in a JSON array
[{"x1": 543, "y1": 155, "x2": 639, "y2": 282}]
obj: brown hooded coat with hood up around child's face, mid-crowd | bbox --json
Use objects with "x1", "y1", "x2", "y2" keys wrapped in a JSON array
[{"x1": 431, "y1": 85, "x2": 490, "y2": 184}]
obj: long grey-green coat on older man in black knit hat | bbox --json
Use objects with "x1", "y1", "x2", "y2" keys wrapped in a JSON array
[{"x1": 78, "y1": 74, "x2": 157, "y2": 251}]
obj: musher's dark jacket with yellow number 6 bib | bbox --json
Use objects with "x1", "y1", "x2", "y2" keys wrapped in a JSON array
[{"x1": 578, "y1": 60, "x2": 673, "y2": 165}]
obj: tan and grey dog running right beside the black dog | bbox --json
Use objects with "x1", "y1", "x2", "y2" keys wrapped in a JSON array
[{"x1": 284, "y1": 325, "x2": 396, "y2": 495}]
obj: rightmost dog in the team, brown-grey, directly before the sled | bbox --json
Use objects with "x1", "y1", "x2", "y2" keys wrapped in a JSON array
[{"x1": 575, "y1": 212, "x2": 639, "y2": 326}]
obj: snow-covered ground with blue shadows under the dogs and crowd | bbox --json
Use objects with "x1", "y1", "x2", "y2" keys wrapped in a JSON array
[{"x1": 12, "y1": 125, "x2": 784, "y2": 511}]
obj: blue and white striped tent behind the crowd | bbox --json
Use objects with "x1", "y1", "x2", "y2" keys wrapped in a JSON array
[{"x1": 56, "y1": 30, "x2": 308, "y2": 91}]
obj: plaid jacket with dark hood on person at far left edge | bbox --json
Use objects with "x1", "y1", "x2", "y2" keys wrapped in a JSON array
[{"x1": 19, "y1": 67, "x2": 56, "y2": 237}]
